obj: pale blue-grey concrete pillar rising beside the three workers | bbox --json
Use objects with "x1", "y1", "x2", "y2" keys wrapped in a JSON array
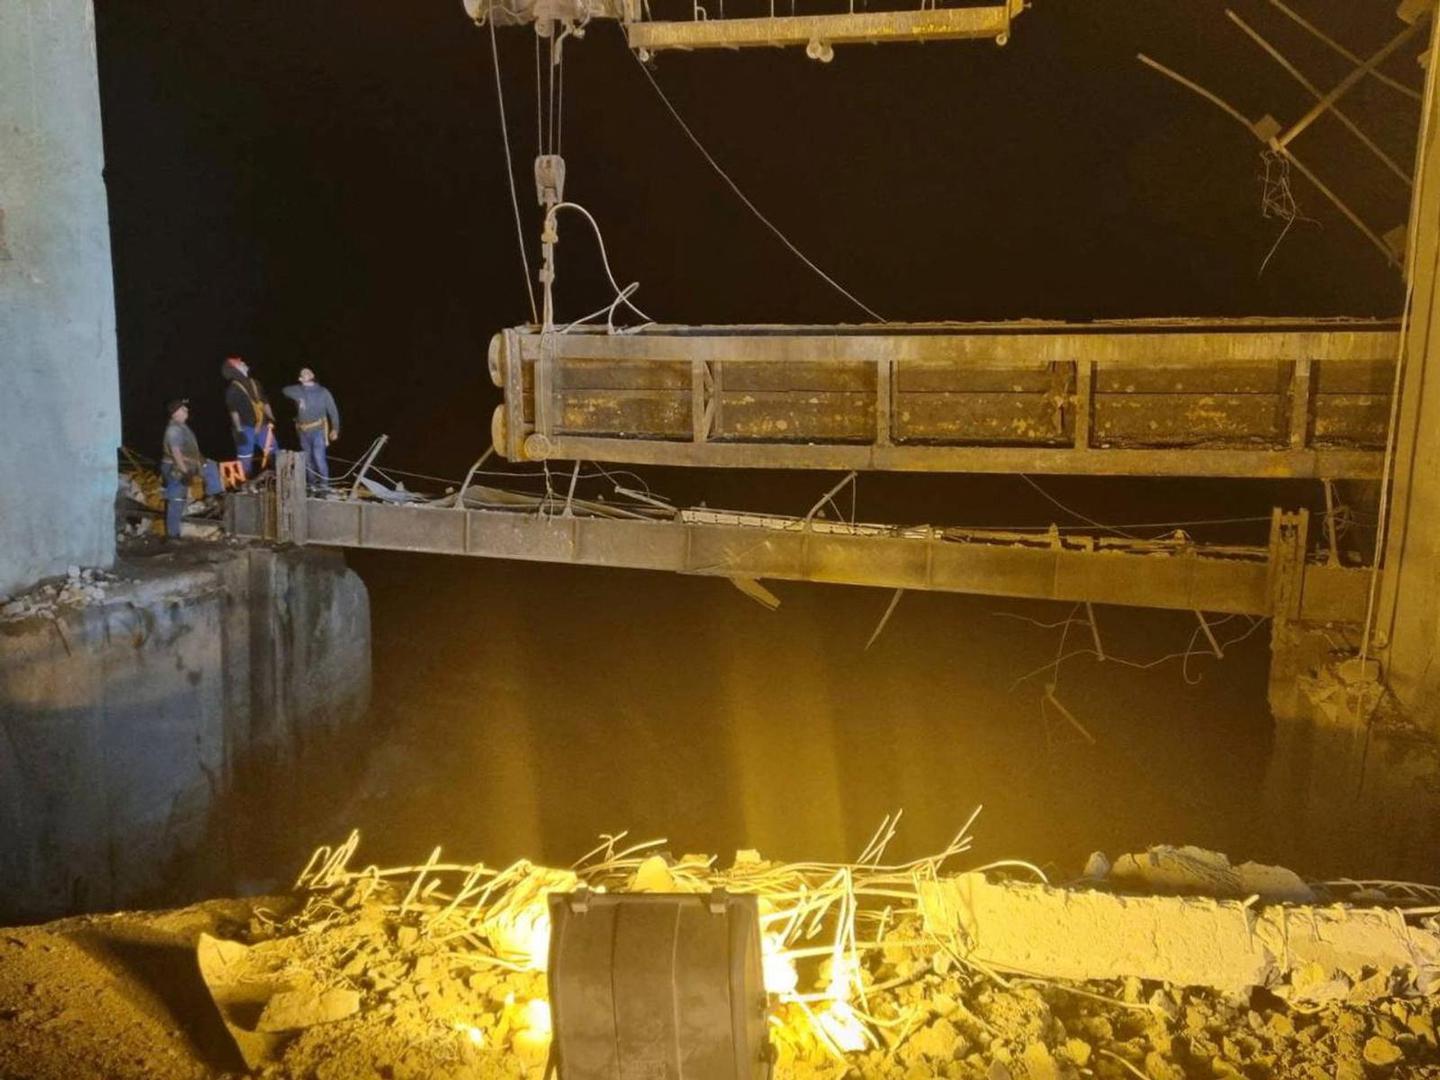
[{"x1": 0, "y1": 0, "x2": 119, "y2": 595}]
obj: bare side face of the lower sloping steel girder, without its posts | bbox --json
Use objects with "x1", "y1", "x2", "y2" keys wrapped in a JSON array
[{"x1": 228, "y1": 492, "x2": 1368, "y2": 622}]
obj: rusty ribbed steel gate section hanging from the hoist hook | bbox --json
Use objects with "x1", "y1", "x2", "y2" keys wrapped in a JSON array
[{"x1": 488, "y1": 320, "x2": 1398, "y2": 480}]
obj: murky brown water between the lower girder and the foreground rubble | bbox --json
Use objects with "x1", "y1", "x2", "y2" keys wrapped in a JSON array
[{"x1": 241, "y1": 553, "x2": 1422, "y2": 898}]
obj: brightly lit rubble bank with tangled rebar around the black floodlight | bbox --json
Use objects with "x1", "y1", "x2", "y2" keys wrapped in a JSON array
[{"x1": 0, "y1": 828, "x2": 1440, "y2": 1080}]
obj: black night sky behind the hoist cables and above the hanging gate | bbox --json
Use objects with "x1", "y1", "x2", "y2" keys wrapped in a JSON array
[{"x1": 98, "y1": 0, "x2": 1418, "y2": 474}]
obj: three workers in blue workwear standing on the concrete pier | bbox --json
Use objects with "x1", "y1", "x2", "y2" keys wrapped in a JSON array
[{"x1": 160, "y1": 356, "x2": 340, "y2": 537}]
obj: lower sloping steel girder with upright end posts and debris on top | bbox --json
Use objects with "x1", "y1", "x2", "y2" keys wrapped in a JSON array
[{"x1": 226, "y1": 451, "x2": 1371, "y2": 714}]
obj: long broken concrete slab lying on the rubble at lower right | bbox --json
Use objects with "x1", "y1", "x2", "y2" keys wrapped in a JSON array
[{"x1": 920, "y1": 873, "x2": 1440, "y2": 1002}]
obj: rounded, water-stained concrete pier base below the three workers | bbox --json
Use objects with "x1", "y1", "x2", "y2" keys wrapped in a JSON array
[{"x1": 0, "y1": 546, "x2": 370, "y2": 923}]
